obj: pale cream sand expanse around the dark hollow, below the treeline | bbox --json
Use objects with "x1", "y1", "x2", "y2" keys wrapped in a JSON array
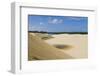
[{"x1": 45, "y1": 34, "x2": 88, "y2": 59}]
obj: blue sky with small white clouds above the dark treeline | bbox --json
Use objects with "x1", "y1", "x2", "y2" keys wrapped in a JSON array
[{"x1": 28, "y1": 15, "x2": 88, "y2": 32}]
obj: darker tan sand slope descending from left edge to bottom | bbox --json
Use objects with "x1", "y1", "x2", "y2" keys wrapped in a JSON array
[{"x1": 28, "y1": 33, "x2": 72, "y2": 60}]
